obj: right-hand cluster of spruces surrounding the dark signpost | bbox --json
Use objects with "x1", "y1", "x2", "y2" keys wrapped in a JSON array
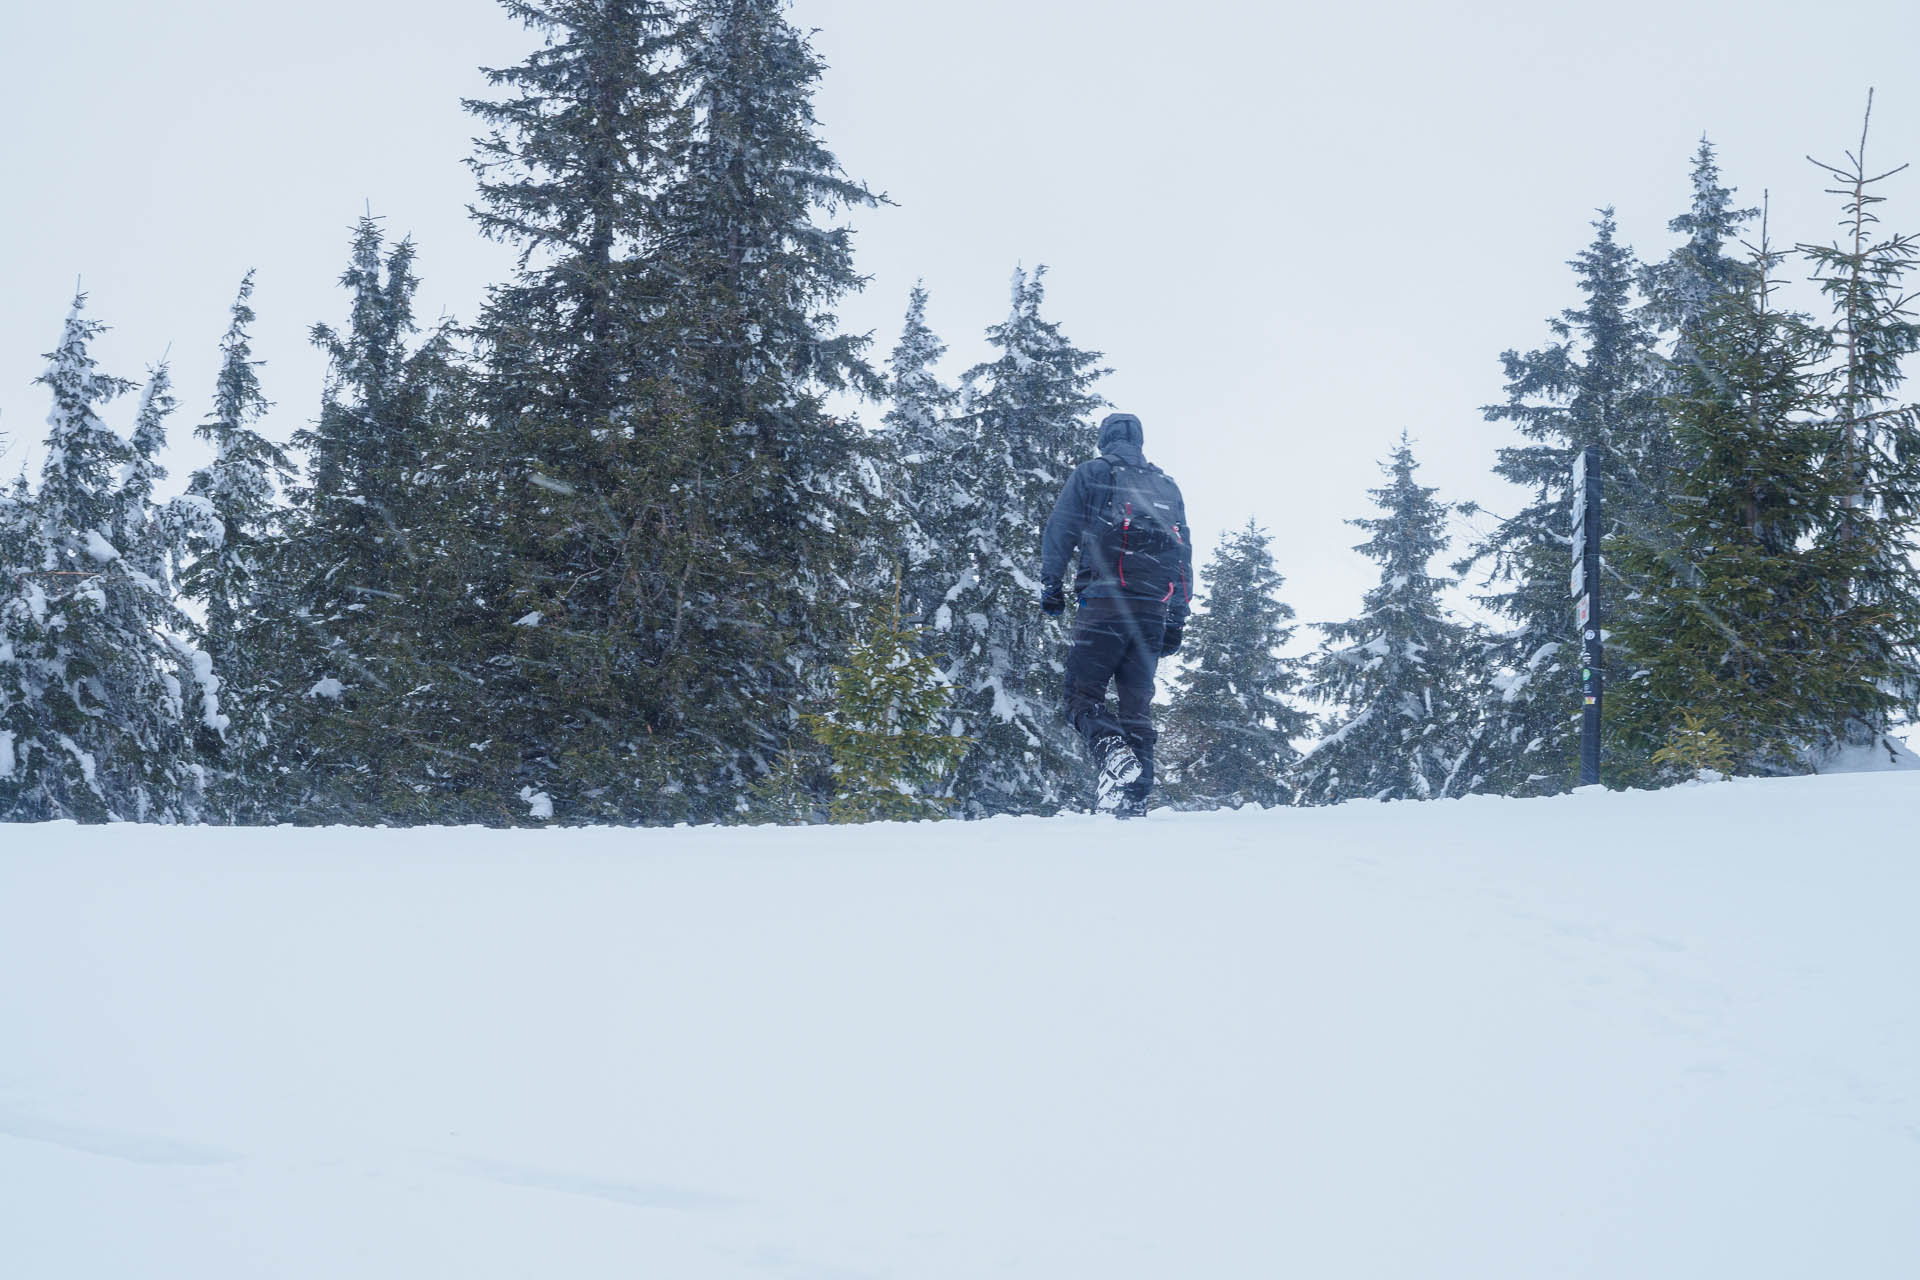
[{"x1": 1290, "y1": 122, "x2": 1920, "y2": 802}]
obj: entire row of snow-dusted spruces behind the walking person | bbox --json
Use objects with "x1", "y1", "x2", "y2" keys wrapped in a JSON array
[{"x1": 0, "y1": 0, "x2": 1920, "y2": 825}]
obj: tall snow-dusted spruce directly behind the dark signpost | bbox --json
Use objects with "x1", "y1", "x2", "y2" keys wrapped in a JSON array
[{"x1": 1455, "y1": 209, "x2": 1672, "y2": 794}]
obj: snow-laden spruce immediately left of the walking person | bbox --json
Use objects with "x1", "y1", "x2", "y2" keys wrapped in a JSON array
[{"x1": 929, "y1": 267, "x2": 1108, "y2": 818}]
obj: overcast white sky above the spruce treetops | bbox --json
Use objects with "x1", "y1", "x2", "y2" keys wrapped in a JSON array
[{"x1": 0, "y1": 0, "x2": 1920, "y2": 637}]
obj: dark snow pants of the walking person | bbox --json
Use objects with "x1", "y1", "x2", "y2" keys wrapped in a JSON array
[{"x1": 1068, "y1": 599, "x2": 1167, "y2": 800}]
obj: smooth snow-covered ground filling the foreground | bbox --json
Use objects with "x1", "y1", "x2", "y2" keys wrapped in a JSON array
[{"x1": 0, "y1": 773, "x2": 1920, "y2": 1280}]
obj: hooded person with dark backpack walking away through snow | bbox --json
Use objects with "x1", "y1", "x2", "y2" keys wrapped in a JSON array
[{"x1": 1041, "y1": 413, "x2": 1192, "y2": 818}]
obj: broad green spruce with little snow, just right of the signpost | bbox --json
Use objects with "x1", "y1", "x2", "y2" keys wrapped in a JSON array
[{"x1": 1611, "y1": 232, "x2": 1887, "y2": 781}]
